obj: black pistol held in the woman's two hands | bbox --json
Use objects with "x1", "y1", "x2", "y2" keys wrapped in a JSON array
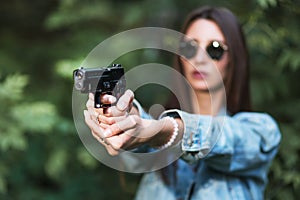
[{"x1": 73, "y1": 64, "x2": 126, "y2": 108}]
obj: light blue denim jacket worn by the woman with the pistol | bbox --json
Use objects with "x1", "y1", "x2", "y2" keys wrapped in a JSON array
[{"x1": 135, "y1": 101, "x2": 281, "y2": 200}]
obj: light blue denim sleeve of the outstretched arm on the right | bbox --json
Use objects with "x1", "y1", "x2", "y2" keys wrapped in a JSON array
[{"x1": 164, "y1": 110, "x2": 281, "y2": 175}]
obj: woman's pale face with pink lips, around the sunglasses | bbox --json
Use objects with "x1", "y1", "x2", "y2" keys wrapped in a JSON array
[{"x1": 181, "y1": 19, "x2": 229, "y2": 91}]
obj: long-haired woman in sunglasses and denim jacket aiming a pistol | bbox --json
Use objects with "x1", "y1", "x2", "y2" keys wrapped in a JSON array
[{"x1": 84, "y1": 7, "x2": 281, "y2": 200}]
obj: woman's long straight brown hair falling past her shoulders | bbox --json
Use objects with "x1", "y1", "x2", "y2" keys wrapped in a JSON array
[{"x1": 161, "y1": 6, "x2": 251, "y2": 184}]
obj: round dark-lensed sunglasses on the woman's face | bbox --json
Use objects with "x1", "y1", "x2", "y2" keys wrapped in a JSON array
[{"x1": 179, "y1": 40, "x2": 228, "y2": 60}]
